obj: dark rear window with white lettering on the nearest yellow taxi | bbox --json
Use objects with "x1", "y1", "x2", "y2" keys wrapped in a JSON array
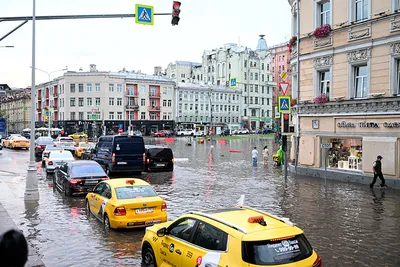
[{"x1": 242, "y1": 234, "x2": 312, "y2": 265}]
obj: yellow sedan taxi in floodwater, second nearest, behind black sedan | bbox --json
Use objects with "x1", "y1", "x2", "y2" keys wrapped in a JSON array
[{"x1": 86, "y1": 178, "x2": 167, "y2": 229}]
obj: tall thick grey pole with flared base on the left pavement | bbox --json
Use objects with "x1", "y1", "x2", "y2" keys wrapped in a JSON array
[{"x1": 24, "y1": 0, "x2": 39, "y2": 201}]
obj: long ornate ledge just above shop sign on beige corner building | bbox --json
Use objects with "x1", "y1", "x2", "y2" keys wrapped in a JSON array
[{"x1": 296, "y1": 97, "x2": 400, "y2": 115}]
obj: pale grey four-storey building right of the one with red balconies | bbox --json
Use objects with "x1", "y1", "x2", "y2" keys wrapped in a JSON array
[{"x1": 176, "y1": 83, "x2": 241, "y2": 134}]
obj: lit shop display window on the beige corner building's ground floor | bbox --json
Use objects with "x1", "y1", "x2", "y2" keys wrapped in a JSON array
[{"x1": 321, "y1": 138, "x2": 362, "y2": 171}]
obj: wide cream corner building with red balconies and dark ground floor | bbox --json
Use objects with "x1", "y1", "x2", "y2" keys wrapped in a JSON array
[{"x1": 36, "y1": 65, "x2": 175, "y2": 135}]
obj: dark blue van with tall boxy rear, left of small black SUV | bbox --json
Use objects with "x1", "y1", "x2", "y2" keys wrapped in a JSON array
[{"x1": 92, "y1": 135, "x2": 145, "y2": 176}]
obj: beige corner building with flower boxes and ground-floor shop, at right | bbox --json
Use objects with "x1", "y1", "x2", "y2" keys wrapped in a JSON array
[{"x1": 289, "y1": 0, "x2": 400, "y2": 182}]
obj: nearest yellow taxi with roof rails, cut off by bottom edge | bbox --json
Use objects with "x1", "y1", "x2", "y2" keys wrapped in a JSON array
[{"x1": 142, "y1": 207, "x2": 322, "y2": 267}]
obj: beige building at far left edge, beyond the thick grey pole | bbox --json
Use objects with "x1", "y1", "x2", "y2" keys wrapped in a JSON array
[{"x1": 0, "y1": 89, "x2": 31, "y2": 133}]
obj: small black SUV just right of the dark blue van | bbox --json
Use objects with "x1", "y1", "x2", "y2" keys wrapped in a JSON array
[{"x1": 145, "y1": 145, "x2": 174, "y2": 171}]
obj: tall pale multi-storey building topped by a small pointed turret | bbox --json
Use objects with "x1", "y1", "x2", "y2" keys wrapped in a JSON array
[{"x1": 202, "y1": 35, "x2": 276, "y2": 129}]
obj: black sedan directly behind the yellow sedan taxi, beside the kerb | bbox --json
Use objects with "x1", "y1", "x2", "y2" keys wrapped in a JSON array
[{"x1": 53, "y1": 160, "x2": 110, "y2": 196}]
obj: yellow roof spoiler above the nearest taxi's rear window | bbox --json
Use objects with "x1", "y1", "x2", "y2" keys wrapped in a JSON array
[{"x1": 242, "y1": 225, "x2": 303, "y2": 241}]
